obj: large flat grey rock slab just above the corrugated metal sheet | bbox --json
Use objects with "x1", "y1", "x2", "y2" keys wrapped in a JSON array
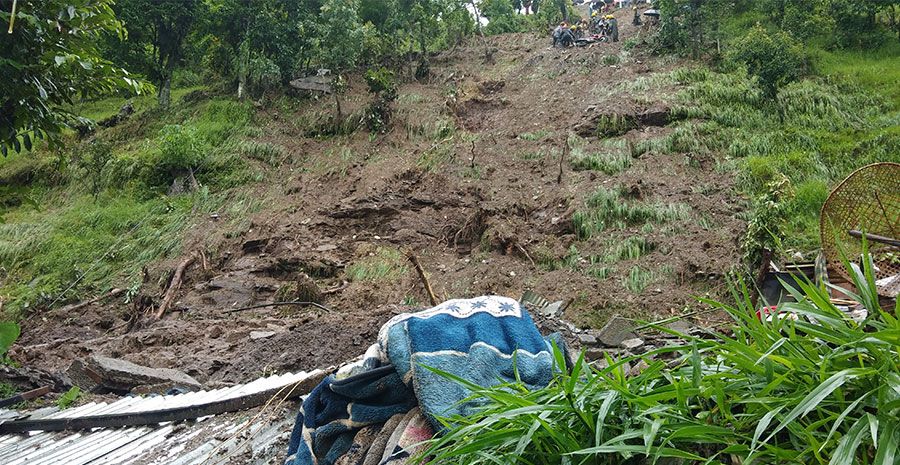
[{"x1": 66, "y1": 355, "x2": 200, "y2": 393}]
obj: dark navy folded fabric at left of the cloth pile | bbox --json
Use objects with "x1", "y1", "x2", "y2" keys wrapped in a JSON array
[{"x1": 285, "y1": 365, "x2": 416, "y2": 465}]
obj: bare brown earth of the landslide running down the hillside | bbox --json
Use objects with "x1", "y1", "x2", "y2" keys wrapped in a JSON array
[{"x1": 13, "y1": 7, "x2": 744, "y2": 386}]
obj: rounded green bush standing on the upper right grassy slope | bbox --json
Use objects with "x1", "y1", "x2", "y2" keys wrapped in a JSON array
[{"x1": 728, "y1": 25, "x2": 806, "y2": 98}]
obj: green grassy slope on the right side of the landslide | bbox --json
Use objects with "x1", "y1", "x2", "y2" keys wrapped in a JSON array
[{"x1": 634, "y1": 57, "x2": 900, "y2": 256}]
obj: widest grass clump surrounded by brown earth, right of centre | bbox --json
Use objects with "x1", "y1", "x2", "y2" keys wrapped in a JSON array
[{"x1": 573, "y1": 187, "x2": 690, "y2": 239}]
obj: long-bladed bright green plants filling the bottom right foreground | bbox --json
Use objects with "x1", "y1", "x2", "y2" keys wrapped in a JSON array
[{"x1": 422, "y1": 254, "x2": 900, "y2": 465}]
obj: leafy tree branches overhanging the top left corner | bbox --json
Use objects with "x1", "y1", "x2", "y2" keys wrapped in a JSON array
[{"x1": 0, "y1": 0, "x2": 150, "y2": 156}]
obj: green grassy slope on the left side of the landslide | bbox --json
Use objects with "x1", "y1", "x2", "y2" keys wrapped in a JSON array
[{"x1": 0, "y1": 89, "x2": 261, "y2": 315}]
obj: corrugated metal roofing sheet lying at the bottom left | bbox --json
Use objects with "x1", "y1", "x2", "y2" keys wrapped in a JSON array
[{"x1": 0, "y1": 370, "x2": 322, "y2": 465}]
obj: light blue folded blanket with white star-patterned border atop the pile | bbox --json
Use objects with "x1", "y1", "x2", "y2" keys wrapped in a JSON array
[{"x1": 378, "y1": 296, "x2": 563, "y2": 431}]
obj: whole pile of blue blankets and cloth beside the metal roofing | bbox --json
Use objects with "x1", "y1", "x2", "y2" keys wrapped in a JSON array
[{"x1": 285, "y1": 296, "x2": 568, "y2": 465}]
